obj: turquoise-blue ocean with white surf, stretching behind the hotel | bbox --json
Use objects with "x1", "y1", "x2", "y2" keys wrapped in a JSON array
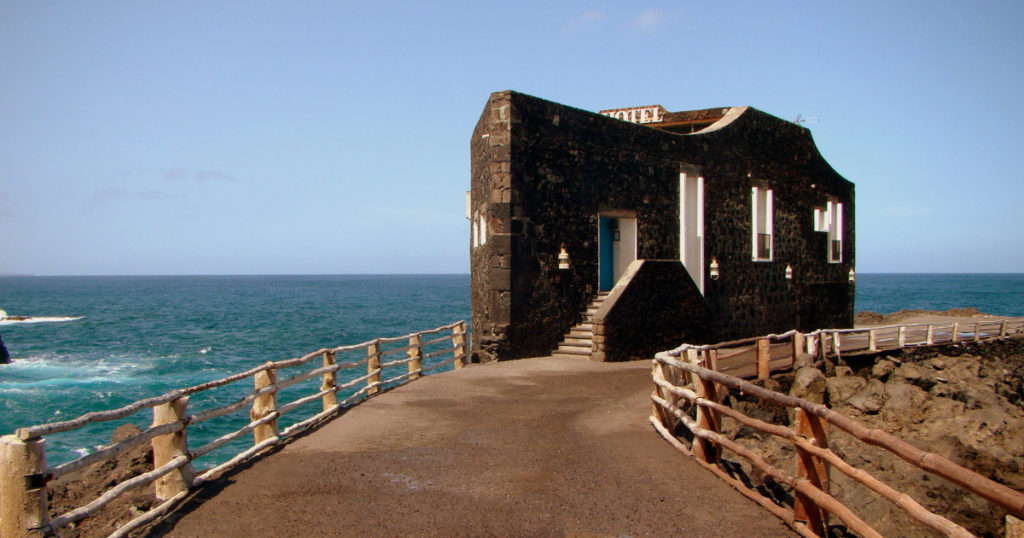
[{"x1": 0, "y1": 274, "x2": 1024, "y2": 467}]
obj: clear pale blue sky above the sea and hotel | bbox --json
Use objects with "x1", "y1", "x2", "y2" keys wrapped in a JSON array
[{"x1": 0, "y1": 0, "x2": 1024, "y2": 275}]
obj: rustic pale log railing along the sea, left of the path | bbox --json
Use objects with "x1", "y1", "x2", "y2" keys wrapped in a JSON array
[{"x1": 0, "y1": 322, "x2": 468, "y2": 538}]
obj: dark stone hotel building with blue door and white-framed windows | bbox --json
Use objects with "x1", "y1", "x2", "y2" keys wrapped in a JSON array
[{"x1": 467, "y1": 91, "x2": 854, "y2": 361}]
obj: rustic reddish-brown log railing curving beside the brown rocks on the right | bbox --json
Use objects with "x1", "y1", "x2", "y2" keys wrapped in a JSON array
[{"x1": 650, "y1": 321, "x2": 1024, "y2": 536}]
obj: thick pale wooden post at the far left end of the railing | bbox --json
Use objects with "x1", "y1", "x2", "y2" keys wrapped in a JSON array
[{"x1": 0, "y1": 436, "x2": 50, "y2": 538}]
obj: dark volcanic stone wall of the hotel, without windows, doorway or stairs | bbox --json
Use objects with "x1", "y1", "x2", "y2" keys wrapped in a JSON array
[{"x1": 470, "y1": 91, "x2": 854, "y2": 361}]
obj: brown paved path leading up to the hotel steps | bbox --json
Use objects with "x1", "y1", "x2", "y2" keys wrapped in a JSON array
[{"x1": 153, "y1": 358, "x2": 794, "y2": 538}]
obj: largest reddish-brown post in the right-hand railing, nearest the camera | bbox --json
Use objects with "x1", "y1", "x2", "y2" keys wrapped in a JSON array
[{"x1": 793, "y1": 408, "x2": 829, "y2": 536}]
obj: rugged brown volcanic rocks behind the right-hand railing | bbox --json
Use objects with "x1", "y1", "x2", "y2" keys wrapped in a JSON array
[{"x1": 723, "y1": 308, "x2": 1024, "y2": 537}]
